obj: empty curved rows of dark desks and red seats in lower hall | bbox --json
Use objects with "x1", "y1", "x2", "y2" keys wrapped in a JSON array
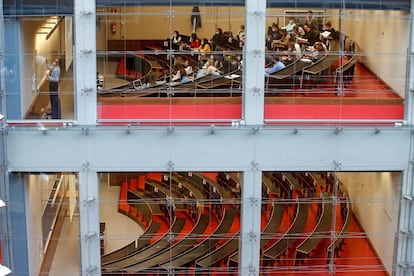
[{"x1": 102, "y1": 172, "x2": 351, "y2": 275}]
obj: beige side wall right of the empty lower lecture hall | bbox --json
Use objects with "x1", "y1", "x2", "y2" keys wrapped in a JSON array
[{"x1": 337, "y1": 172, "x2": 402, "y2": 274}]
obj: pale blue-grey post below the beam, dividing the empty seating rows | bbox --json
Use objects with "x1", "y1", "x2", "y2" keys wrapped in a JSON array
[{"x1": 239, "y1": 166, "x2": 262, "y2": 276}]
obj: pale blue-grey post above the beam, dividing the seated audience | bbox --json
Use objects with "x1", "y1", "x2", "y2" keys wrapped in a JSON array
[{"x1": 243, "y1": 0, "x2": 266, "y2": 125}]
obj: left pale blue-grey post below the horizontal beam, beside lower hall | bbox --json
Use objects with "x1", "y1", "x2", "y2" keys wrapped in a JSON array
[{"x1": 79, "y1": 169, "x2": 101, "y2": 275}]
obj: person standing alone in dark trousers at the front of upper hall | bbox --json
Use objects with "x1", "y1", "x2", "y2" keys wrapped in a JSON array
[{"x1": 46, "y1": 58, "x2": 62, "y2": 119}]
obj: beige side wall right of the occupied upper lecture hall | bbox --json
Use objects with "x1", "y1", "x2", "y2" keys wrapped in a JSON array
[{"x1": 341, "y1": 10, "x2": 410, "y2": 97}]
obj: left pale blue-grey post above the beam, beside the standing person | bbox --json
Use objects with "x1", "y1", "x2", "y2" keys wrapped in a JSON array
[{"x1": 73, "y1": 0, "x2": 97, "y2": 125}]
